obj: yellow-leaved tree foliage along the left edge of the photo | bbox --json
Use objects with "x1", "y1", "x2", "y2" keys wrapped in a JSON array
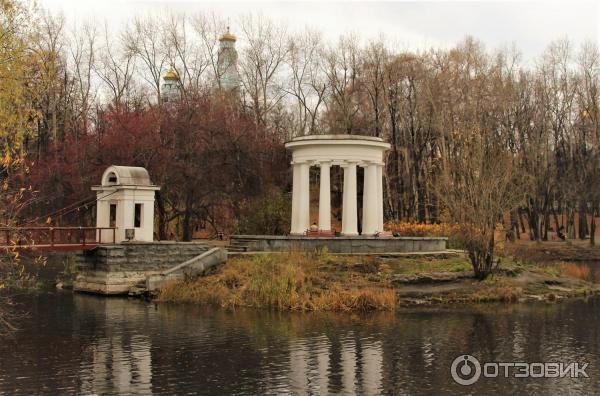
[{"x1": 0, "y1": 0, "x2": 49, "y2": 335}]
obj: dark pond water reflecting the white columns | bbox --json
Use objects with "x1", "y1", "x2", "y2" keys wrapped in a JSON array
[{"x1": 0, "y1": 291, "x2": 600, "y2": 395}]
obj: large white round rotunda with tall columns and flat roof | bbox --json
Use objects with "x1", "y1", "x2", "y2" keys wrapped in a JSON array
[{"x1": 285, "y1": 135, "x2": 390, "y2": 236}]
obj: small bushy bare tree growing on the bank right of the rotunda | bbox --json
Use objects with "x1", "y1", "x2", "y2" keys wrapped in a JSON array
[{"x1": 436, "y1": 128, "x2": 523, "y2": 279}]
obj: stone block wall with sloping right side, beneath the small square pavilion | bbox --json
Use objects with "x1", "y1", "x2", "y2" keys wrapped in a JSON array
[{"x1": 73, "y1": 242, "x2": 209, "y2": 294}]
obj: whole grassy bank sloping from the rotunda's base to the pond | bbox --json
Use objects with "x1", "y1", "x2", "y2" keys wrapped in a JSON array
[{"x1": 158, "y1": 253, "x2": 600, "y2": 312}]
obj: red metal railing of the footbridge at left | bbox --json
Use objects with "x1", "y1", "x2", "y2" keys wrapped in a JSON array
[{"x1": 0, "y1": 227, "x2": 116, "y2": 250}]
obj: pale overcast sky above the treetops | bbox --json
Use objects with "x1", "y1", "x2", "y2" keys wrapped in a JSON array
[{"x1": 40, "y1": 0, "x2": 600, "y2": 61}]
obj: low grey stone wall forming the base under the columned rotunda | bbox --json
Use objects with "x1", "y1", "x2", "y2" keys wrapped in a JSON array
[{"x1": 231, "y1": 235, "x2": 448, "y2": 253}]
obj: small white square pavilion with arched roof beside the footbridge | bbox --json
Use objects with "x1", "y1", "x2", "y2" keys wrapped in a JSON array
[{"x1": 92, "y1": 165, "x2": 160, "y2": 243}]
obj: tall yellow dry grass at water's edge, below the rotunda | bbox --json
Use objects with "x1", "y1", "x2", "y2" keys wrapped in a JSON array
[{"x1": 159, "y1": 253, "x2": 396, "y2": 311}]
